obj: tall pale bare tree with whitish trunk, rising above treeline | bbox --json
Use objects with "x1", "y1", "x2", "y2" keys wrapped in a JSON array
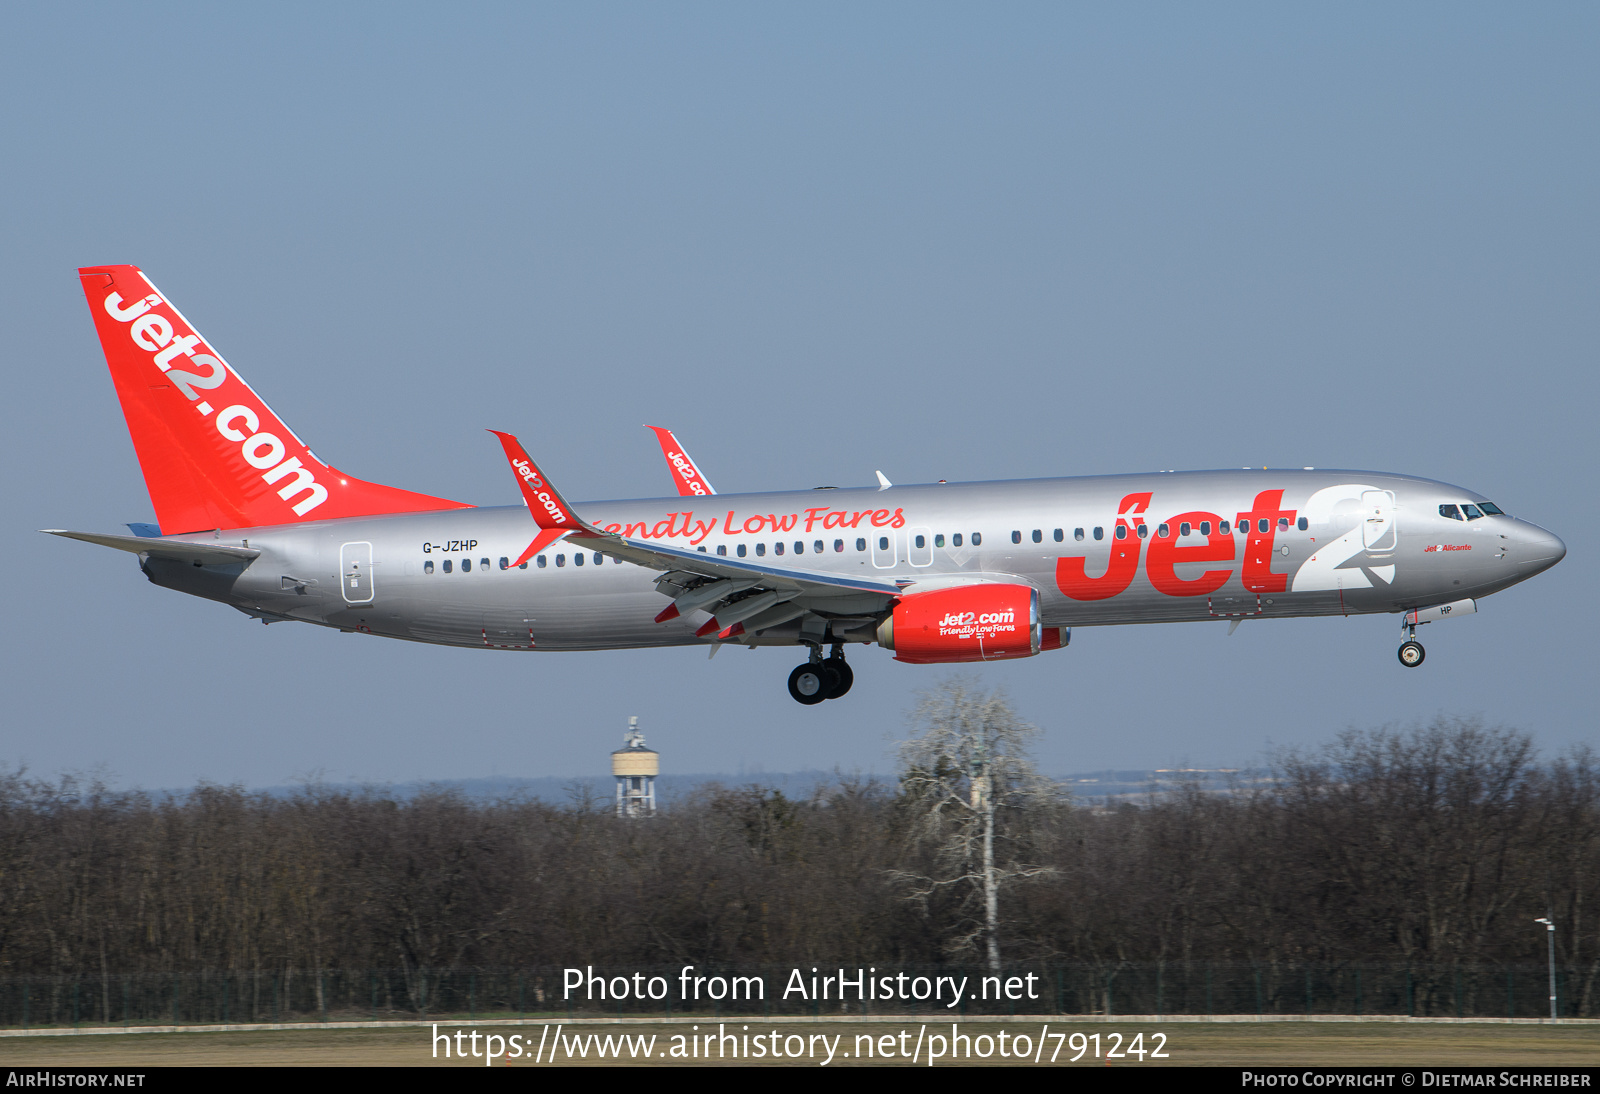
[{"x1": 893, "y1": 678, "x2": 1061, "y2": 972}]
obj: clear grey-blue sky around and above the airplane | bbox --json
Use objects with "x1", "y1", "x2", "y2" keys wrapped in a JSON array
[{"x1": 0, "y1": 3, "x2": 1600, "y2": 785}]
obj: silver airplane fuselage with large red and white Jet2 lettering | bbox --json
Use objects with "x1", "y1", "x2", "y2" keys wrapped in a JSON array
[{"x1": 142, "y1": 470, "x2": 1565, "y2": 649}]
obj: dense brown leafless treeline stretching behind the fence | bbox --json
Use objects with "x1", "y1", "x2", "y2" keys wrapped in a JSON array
[{"x1": 0, "y1": 721, "x2": 1600, "y2": 1012}]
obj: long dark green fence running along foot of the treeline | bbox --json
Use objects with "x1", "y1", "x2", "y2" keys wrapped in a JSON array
[{"x1": 0, "y1": 963, "x2": 1597, "y2": 1028}]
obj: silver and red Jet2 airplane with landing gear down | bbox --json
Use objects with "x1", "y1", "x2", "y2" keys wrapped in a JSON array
[{"x1": 53, "y1": 266, "x2": 1566, "y2": 705}]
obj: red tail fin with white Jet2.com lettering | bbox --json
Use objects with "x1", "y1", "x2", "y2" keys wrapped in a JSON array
[{"x1": 78, "y1": 266, "x2": 470, "y2": 536}]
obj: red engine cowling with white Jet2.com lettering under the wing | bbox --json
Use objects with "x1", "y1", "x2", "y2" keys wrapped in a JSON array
[{"x1": 878, "y1": 585, "x2": 1043, "y2": 665}]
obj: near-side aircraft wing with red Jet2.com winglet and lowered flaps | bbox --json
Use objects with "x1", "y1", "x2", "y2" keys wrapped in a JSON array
[{"x1": 490, "y1": 430, "x2": 901, "y2": 638}]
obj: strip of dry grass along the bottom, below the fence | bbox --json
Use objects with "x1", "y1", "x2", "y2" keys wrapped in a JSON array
[{"x1": 0, "y1": 1019, "x2": 1600, "y2": 1068}]
